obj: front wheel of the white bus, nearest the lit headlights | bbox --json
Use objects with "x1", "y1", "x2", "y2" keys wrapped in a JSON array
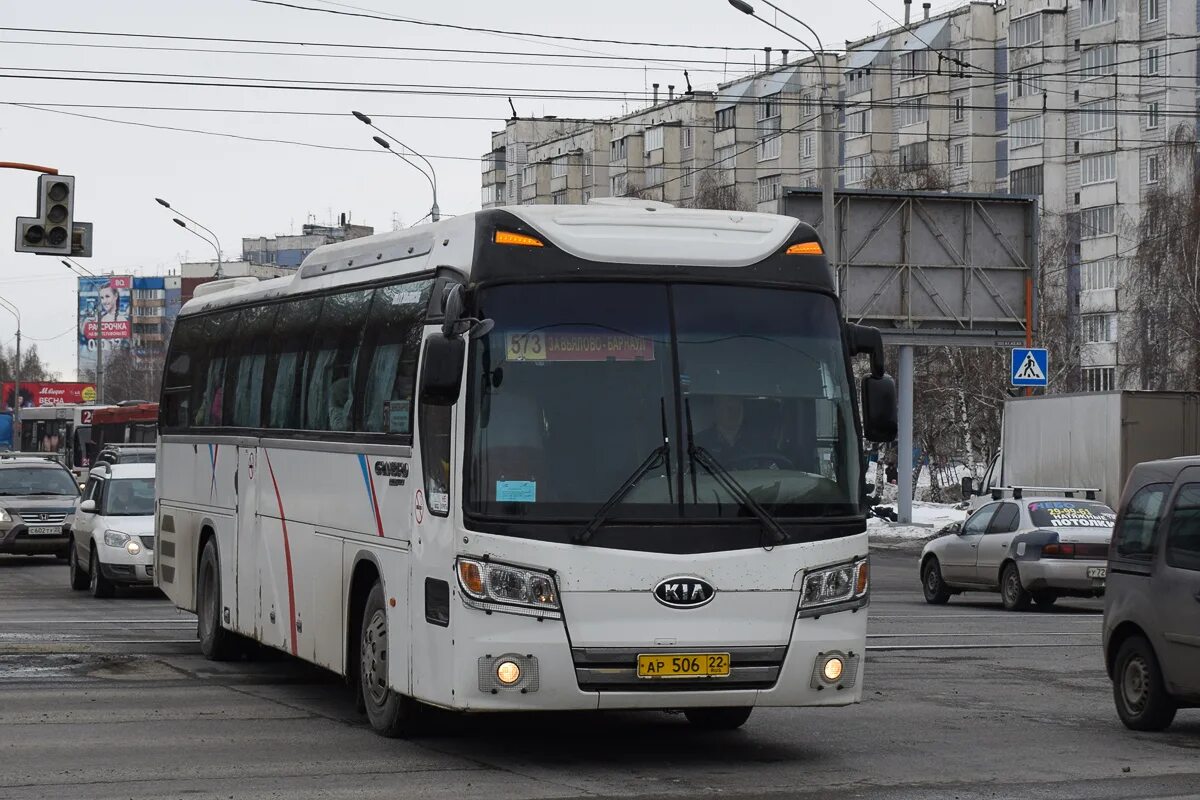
[{"x1": 359, "y1": 581, "x2": 419, "y2": 739}]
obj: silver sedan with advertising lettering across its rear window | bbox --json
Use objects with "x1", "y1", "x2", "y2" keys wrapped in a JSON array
[{"x1": 920, "y1": 489, "x2": 1116, "y2": 610}]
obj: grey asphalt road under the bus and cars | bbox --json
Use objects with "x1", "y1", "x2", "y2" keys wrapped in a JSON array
[{"x1": 0, "y1": 551, "x2": 1200, "y2": 800}]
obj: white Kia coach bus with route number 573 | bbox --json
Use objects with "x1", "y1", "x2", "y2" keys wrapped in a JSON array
[{"x1": 155, "y1": 201, "x2": 895, "y2": 735}]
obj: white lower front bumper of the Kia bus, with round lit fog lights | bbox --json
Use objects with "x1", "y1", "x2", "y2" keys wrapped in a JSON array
[{"x1": 451, "y1": 607, "x2": 866, "y2": 711}]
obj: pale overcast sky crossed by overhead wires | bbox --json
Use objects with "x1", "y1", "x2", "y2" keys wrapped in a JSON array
[{"x1": 0, "y1": 0, "x2": 936, "y2": 380}]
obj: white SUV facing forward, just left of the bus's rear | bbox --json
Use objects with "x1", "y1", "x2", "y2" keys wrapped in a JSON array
[{"x1": 67, "y1": 464, "x2": 155, "y2": 597}]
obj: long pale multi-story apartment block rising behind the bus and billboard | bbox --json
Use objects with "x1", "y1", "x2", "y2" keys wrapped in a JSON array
[{"x1": 484, "y1": 0, "x2": 1200, "y2": 391}]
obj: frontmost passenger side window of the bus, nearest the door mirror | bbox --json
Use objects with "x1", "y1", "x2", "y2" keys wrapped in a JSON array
[{"x1": 358, "y1": 279, "x2": 433, "y2": 437}]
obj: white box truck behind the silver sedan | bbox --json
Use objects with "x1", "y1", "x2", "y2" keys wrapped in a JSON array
[{"x1": 962, "y1": 391, "x2": 1200, "y2": 510}]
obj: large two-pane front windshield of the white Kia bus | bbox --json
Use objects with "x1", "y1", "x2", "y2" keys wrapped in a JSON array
[{"x1": 464, "y1": 283, "x2": 862, "y2": 522}]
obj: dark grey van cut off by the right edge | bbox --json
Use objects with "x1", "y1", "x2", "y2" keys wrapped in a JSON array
[{"x1": 1104, "y1": 457, "x2": 1200, "y2": 730}]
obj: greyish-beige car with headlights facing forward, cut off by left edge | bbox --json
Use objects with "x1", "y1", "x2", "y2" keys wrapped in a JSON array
[{"x1": 0, "y1": 456, "x2": 79, "y2": 558}]
